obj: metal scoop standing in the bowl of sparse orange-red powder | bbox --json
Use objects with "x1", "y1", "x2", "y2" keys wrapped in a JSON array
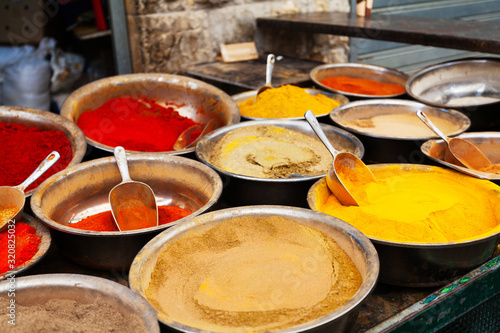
[{"x1": 109, "y1": 146, "x2": 158, "y2": 231}]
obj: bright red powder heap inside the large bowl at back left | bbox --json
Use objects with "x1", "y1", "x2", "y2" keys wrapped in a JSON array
[{"x1": 77, "y1": 97, "x2": 201, "y2": 152}]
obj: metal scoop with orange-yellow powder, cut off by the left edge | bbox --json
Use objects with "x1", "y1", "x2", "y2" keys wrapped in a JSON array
[{"x1": 0, "y1": 151, "x2": 60, "y2": 232}]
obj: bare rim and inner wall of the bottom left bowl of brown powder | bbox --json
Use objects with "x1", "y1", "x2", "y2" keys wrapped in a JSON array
[{"x1": 0, "y1": 274, "x2": 160, "y2": 333}]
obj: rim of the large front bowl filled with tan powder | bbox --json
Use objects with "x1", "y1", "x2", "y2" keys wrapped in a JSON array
[{"x1": 129, "y1": 205, "x2": 380, "y2": 333}]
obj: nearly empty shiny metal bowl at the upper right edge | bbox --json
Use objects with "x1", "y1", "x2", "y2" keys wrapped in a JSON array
[{"x1": 406, "y1": 59, "x2": 500, "y2": 131}]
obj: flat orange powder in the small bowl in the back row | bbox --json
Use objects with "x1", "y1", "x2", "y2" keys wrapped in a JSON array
[{"x1": 320, "y1": 76, "x2": 406, "y2": 96}]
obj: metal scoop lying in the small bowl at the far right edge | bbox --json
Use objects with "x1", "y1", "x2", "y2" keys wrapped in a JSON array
[{"x1": 417, "y1": 110, "x2": 492, "y2": 171}]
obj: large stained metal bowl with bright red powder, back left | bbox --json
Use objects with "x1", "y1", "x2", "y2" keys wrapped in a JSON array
[{"x1": 61, "y1": 73, "x2": 240, "y2": 154}]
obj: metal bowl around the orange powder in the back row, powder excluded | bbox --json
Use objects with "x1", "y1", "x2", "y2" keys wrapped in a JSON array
[{"x1": 309, "y1": 63, "x2": 408, "y2": 99}]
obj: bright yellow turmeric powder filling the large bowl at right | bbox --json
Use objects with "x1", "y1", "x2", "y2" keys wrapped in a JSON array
[{"x1": 315, "y1": 165, "x2": 500, "y2": 243}]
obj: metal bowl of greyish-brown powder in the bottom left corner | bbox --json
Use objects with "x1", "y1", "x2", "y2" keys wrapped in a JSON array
[{"x1": 0, "y1": 274, "x2": 160, "y2": 333}]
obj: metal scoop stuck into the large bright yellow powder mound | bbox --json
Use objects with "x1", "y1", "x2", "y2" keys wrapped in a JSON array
[{"x1": 304, "y1": 110, "x2": 377, "y2": 206}]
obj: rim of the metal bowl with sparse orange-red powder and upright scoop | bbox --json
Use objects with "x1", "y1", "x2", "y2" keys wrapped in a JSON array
[{"x1": 30, "y1": 153, "x2": 222, "y2": 237}]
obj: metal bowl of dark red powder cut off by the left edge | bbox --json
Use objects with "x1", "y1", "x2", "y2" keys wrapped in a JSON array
[{"x1": 0, "y1": 106, "x2": 87, "y2": 196}]
